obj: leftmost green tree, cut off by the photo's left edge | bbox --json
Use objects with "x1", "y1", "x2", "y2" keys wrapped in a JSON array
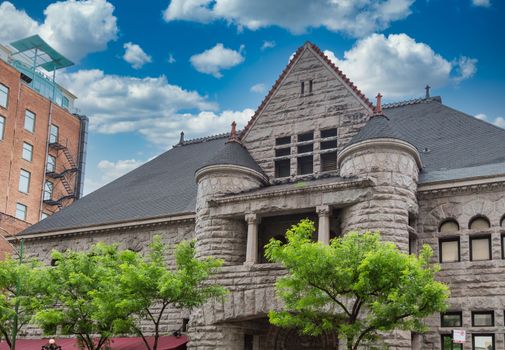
[{"x1": 0, "y1": 252, "x2": 48, "y2": 350}]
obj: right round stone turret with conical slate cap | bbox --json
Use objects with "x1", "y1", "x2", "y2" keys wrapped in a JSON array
[{"x1": 339, "y1": 114, "x2": 422, "y2": 251}]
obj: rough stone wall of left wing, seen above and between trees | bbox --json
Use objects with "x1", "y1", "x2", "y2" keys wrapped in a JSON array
[{"x1": 21, "y1": 220, "x2": 194, "y2": 337}]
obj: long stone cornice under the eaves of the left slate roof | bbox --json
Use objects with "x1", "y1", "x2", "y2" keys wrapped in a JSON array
[{"x1": 7, "y1": 213, "x2": 195, "y2": 242}]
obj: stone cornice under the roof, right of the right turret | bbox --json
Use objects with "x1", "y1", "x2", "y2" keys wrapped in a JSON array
[{"x1": 417, "y1": 177, "x2": 505, "y2": 198}]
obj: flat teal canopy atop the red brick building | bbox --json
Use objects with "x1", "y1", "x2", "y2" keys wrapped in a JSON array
[{"x1": 10, "y1": 35, "x2": 74, "y2": 72}]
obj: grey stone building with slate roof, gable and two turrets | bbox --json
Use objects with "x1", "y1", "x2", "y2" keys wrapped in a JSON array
[{"x1": 10, "y1": 43, "x2": 505, "y2": 350}]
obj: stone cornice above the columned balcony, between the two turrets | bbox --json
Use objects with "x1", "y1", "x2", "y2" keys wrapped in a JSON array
[{"x1": 211, "y1": 179, "x2": 373, "y2": 205}]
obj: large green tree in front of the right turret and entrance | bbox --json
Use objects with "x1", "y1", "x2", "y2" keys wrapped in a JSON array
[{"x1": 266, "y1": 220, "x2": 449, "y2": 350}]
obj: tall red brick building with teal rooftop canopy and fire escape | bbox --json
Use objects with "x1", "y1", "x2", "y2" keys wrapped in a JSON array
[{"x1": 0, "y1": 36, "x2": 87, "y2": 254}]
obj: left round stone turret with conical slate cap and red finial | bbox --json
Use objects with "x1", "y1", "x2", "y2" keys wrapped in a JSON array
[{"x1": 195, "y1": 142, "x2": 268, "y2": 265}]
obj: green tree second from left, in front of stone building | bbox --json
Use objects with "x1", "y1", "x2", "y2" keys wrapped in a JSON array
[{"x1": 35, "y1": 243, "x2": 136, "y2": 350}]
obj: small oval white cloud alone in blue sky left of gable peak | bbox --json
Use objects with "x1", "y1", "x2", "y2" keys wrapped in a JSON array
[{"x1": 190, "y1": 43, "x2": 244, "y2": 78}]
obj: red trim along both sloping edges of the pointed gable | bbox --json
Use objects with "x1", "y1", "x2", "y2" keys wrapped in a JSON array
[{"x1": 239, "y1": 41, "x2": 374, "y2": 139}]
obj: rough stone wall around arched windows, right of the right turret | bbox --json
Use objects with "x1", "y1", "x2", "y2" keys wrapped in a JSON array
[{"x1": 417, "y1": 186, "x2": 505, "y2": 350}]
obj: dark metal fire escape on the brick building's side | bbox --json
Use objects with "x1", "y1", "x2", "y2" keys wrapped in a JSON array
[{"x1": 44, "y1": 140, "x2": 80, "y2": 208}]
